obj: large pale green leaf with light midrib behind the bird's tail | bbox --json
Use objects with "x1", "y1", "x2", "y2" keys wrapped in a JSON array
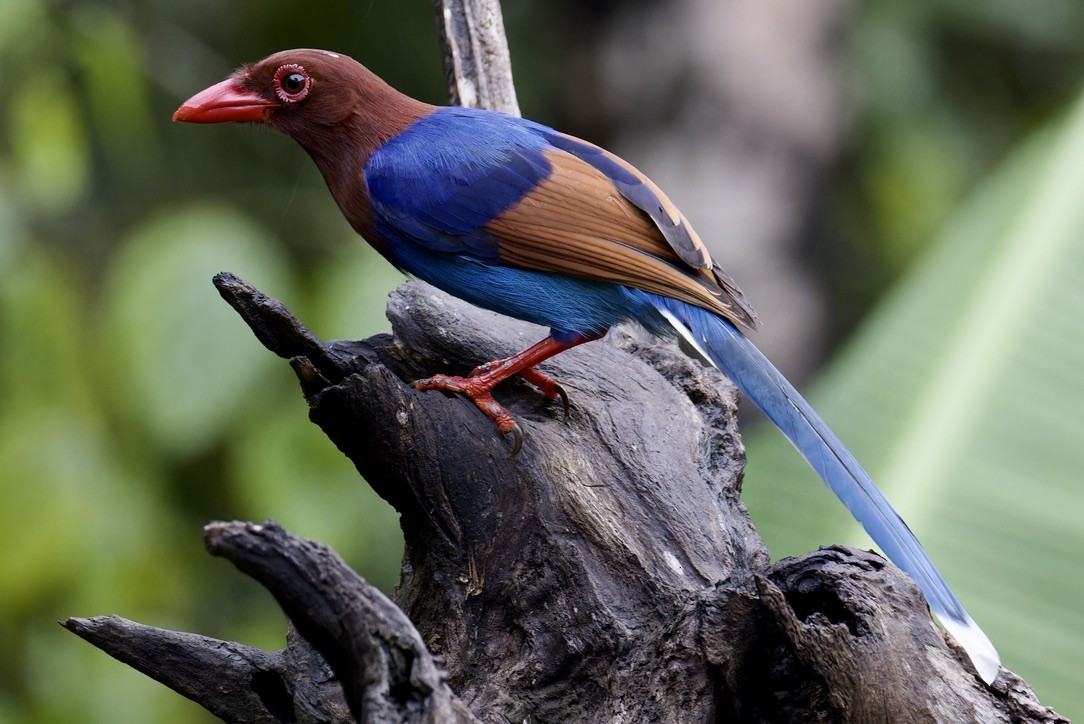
[{"x1": 746, "y1": 87, "x2": 1084, "y2": 716}]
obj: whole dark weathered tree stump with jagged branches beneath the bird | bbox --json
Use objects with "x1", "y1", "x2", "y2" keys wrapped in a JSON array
[{"x1": 67, "y1": 274, "x2": 1064, "y2": 722}]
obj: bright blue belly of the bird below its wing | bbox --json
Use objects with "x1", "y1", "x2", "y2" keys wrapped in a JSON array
[{"x1": 388, "y1": 237, "x2": 662, "y2": 340}]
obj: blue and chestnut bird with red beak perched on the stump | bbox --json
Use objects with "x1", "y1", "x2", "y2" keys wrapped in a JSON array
[{"x1": 173, "y1": 49, "x2": 1001, "y2": 684}]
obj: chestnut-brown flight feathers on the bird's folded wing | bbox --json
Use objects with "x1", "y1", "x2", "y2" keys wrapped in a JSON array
[{"x1": 487, "y1": 151, "x2": 757, "y2": 327}]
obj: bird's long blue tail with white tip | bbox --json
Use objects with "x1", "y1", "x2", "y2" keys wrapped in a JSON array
[{"x1": 647, "y1": 294, "x2": 1001, "y2": 684}]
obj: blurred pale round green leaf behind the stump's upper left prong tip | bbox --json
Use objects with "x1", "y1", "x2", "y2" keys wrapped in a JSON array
[{"x1": 103, "y1": 206, "x2": 293, "y2": 455}]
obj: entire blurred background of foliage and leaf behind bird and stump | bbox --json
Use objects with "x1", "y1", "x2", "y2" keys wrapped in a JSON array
[{"x1": 0, "y1": 0, "x2": 1084, "y2": 722}]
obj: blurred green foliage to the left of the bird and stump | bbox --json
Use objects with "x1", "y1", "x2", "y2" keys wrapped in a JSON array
[{"x1": 0, "y1": 0, "x2": 443, "y2": 722}]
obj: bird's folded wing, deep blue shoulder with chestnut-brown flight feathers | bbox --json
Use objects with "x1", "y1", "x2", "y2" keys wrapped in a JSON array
[{"x1": 365, "y1": 107, "x2": 756, "y2": 326}]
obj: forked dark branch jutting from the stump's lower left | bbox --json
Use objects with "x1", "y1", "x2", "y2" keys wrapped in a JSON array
[{"x1": 62, "y1": 521, "x2": 477, "y2": 724}]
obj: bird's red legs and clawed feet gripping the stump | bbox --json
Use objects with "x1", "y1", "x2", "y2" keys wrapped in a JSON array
[{"x1": 414, "y1": 335, "x2": 602, "y2": 455}]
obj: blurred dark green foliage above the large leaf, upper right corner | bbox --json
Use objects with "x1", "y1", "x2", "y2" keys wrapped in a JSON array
[{"x1": 808, "y1": 0, "x2": 1084, "y2": 337}]
